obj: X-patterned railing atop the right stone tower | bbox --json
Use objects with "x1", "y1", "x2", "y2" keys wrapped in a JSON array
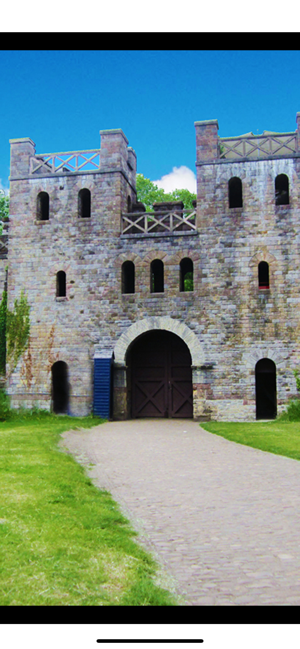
[{"x1": 220, "y1": 132, "x2": 297, "y2": 160}]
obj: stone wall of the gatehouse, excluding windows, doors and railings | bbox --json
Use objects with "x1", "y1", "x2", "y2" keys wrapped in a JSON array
[{"x1": 6, "y1": 115, "x2": 300, "y2": 420}]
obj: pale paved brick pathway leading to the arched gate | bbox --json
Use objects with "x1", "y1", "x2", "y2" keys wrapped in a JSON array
[{"x1": 62, "y1": 420, "x2": 300, "y2": 605}]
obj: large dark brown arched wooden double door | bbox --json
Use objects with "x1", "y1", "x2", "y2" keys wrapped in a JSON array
[{"x1": 131, "y1": 331, "x2": 193, "y2": 418}]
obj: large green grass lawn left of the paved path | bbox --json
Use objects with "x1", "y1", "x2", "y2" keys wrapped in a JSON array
[{"x1": 0, "y1": 413, "x2": 176, "y2": 606}]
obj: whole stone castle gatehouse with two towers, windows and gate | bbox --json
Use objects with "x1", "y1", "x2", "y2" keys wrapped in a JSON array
[{"x1": 5, "y1": 113, "x2": 300, "y2": 421}]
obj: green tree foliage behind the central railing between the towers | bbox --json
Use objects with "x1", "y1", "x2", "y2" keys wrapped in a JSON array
[{"x1": 136, "y1": 174, "x2": 197, "y2": 212}]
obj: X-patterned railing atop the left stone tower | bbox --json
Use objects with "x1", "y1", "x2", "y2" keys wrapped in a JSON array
[{"x1": 30, "y1": 149, "x2": 100, "y2": 175}]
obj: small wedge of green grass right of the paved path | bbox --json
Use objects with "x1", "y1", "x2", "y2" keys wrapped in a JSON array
[{"x1": 201, "y1": 419, "x2": 300, "y2": 460}]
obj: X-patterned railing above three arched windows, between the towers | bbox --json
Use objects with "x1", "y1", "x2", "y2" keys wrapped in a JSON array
[{"x1": 122, "y1": 210, "x2": 196, "y2": 234}]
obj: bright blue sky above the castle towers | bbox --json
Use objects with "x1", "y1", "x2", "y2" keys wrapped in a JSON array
[{"x1": 0, "y1": 50, "x2": 300, "y2": 194}]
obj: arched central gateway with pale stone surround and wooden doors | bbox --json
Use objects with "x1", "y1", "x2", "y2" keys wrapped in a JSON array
[{"x1": 113, "y1": 316, "x2": 205, "y2": 419}]
